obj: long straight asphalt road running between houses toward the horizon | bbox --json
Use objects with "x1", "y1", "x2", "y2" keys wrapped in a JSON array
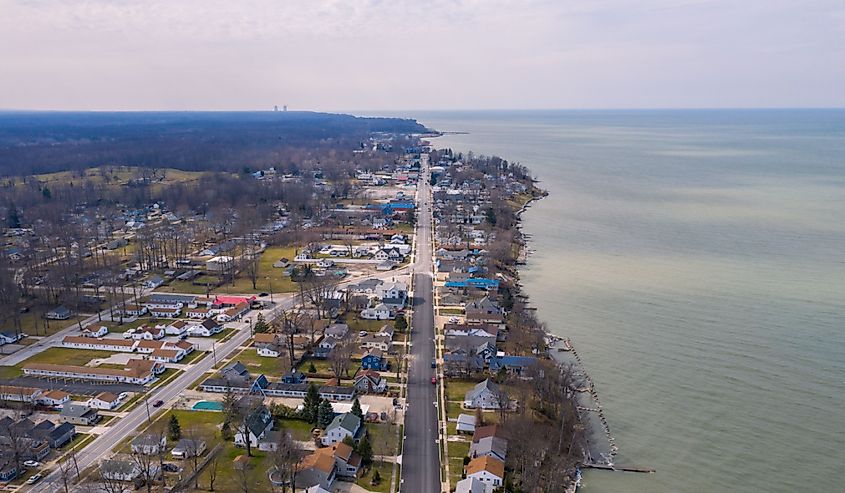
[{"x1": 400, "y1": 155, "x2": 441, "y2": 493}]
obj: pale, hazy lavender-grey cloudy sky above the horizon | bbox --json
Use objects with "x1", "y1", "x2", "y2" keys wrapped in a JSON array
[{"x1": 0, "y1": 0, "x2": 845, "y2": 111}]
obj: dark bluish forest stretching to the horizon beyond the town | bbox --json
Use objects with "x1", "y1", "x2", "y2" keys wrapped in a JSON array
[{"x1": 0, "y1": 111, "x2": 428, "y2": 176}]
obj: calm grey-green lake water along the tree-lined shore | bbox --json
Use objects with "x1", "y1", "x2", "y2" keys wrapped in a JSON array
[{"x1": 398, "y1": 110, "x2": 845, "y2": 493}]
